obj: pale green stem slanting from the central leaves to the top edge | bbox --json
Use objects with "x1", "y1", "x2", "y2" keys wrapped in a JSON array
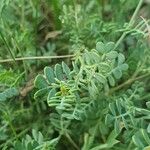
[{"x1": 114, "y1": 0, "x2": 143, "y2": 50}]
